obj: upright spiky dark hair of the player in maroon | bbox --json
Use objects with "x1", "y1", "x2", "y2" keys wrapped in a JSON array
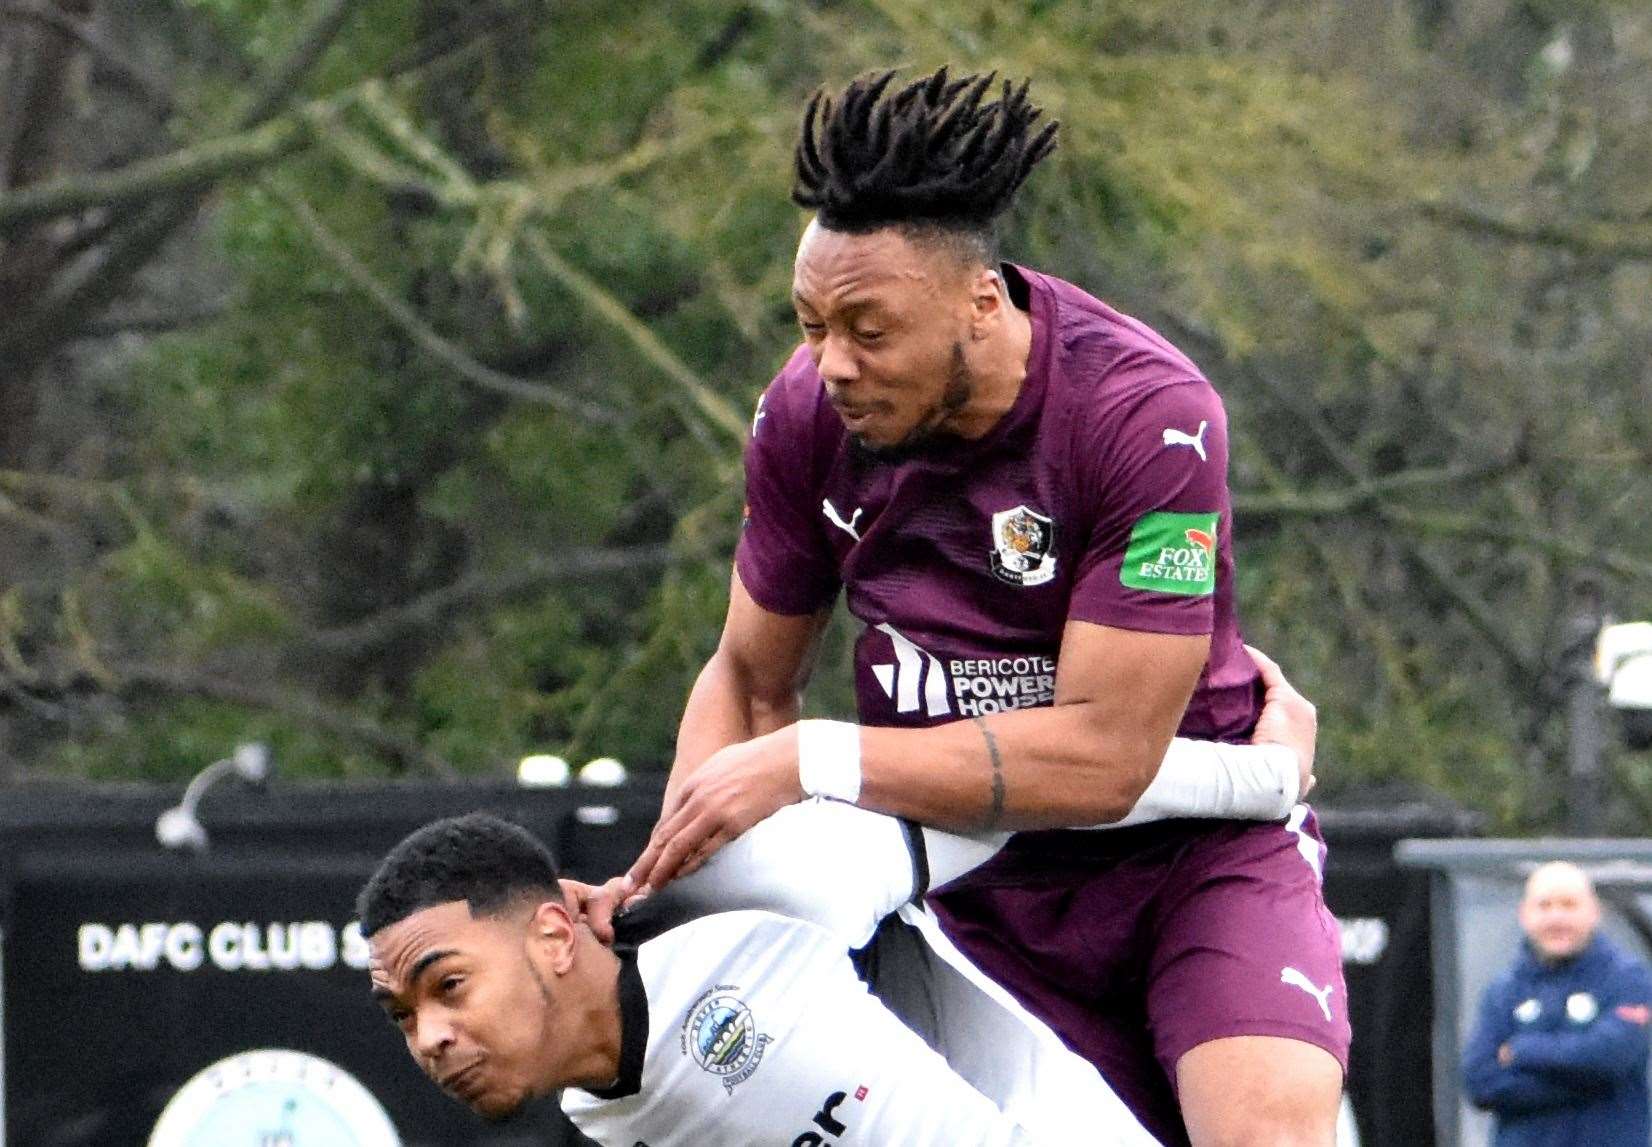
[{"x1": 791, "y1": 68, "x2": 1061, "y2": 251}]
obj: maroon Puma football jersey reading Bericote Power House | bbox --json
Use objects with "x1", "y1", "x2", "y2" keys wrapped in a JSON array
[{"x1": 735, "y1": 266, "x2": 1259, "y2": 740}]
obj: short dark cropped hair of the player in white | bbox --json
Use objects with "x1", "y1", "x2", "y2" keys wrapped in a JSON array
[{"x1": 355, "y1": 813, "x2": 562, "y2": 935}]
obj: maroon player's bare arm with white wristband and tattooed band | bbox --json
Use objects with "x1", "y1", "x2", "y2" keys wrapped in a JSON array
[{"x1": 629, "y1": 621, "x2": 1189, "y2": 888}]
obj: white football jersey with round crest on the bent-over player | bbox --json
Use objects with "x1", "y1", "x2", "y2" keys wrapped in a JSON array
[{"x1": 562, "y1": 800, "x2": 1156, "y2": 1147}]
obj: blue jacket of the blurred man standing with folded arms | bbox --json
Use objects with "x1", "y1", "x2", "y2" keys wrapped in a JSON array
[{"x1": 1462, "y1": 935, "x2": 1652, "y2": 1147}]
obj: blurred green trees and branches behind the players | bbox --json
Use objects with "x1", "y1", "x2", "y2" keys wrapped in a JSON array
[{"x1": 19, "y1": 0, "x2": 1652, "y2": 828}]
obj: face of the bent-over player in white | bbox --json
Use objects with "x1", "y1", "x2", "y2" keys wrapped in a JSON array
[{"x1": 368, "y1": 901, "x2": 567, "y2": 1119}]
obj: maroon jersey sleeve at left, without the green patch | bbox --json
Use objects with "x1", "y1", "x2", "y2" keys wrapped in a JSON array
[{"x1": 733, "y1": 355, "x2": 838, "y2": 615}]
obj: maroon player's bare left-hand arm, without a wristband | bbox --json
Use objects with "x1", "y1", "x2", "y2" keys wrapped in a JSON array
[{"x1": 666, "y1": 570, "x2": 831, "y2": 805}]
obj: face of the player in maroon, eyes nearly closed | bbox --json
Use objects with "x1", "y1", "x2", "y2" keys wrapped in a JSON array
[{"x1": 791, "y1": 223, "x2": 980, "y2": 453}]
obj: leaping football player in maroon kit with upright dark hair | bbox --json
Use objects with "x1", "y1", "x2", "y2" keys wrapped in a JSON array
[{"x1": 614, "y1": 69, "x2": 1350, "y2": 1147}]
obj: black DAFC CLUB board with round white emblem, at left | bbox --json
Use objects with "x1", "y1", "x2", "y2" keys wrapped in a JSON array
[{"x1": 0, "y1": 787, "x2": 657, "y2": 1147}]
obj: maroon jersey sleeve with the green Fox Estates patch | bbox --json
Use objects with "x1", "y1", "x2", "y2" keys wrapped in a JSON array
[{"x1": 1067, "y1": 378, "x2": 1232, "y2": 635}]
